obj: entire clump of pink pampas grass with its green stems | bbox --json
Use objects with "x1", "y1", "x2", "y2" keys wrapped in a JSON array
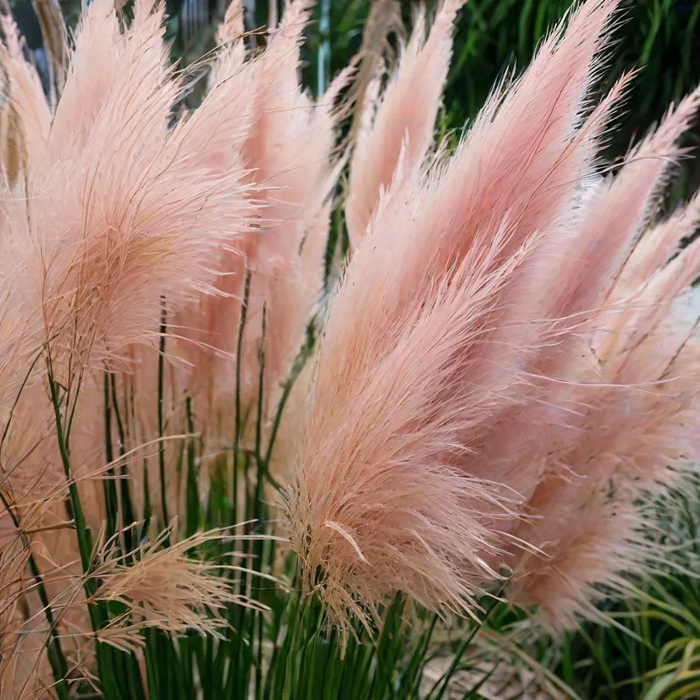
[{"x1": 0, "y1": 0, "x2": 700, "y2": 700}]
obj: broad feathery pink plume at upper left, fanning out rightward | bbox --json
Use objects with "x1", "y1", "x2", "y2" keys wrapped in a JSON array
[{"x1": 4, "y1": 3, "x2": 249, "y2": 382}]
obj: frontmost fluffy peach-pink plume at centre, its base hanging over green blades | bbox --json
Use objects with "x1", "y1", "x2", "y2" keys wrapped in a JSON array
[{"x1": 290, "y1": 232, "x2": 540, "y2": 624}]
